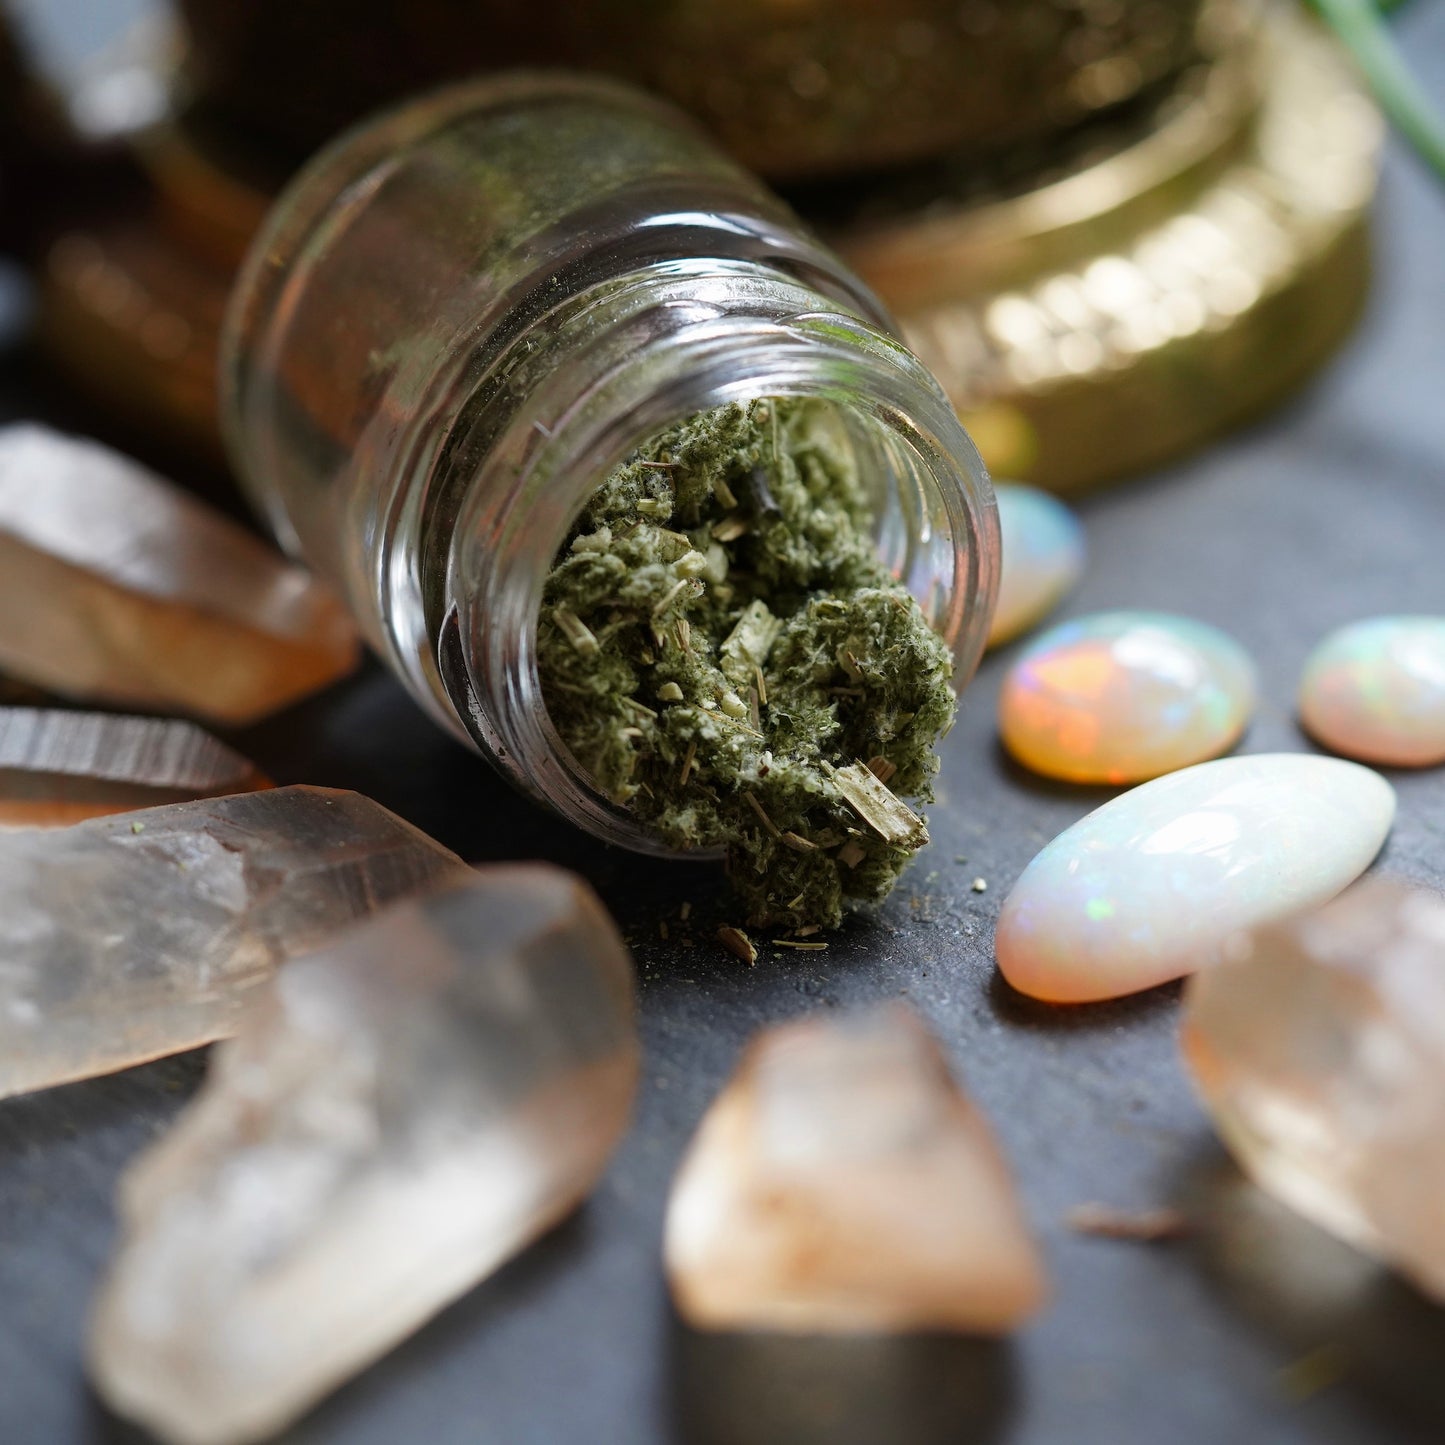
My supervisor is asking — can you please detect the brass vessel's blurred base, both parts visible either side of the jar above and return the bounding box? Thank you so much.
[42,0,1381,491]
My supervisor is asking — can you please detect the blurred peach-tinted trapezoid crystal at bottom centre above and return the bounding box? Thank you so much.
[666,1006,1045,1334]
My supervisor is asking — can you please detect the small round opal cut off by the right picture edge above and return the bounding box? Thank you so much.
[1299,617,1445,767]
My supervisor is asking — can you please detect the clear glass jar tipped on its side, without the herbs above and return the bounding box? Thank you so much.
[223,74,998,853]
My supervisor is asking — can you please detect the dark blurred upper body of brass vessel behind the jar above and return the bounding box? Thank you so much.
[181,0,1201,179]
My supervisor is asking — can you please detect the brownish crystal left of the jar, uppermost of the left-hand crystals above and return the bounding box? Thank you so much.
[0,425,358,724]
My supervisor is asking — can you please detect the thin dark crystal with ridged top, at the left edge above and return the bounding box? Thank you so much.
[0,708,270,828]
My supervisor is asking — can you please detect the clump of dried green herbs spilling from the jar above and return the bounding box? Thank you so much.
[538,399,954,933]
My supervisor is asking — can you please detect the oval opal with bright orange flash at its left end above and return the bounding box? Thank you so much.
[998,613,1254,783]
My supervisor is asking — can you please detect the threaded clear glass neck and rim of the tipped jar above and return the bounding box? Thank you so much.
[419,262,997,853]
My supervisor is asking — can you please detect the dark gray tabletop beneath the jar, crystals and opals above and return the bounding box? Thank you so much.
[0,14,1445,1445]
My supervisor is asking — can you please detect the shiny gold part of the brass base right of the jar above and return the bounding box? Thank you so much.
[831,6,1383,491]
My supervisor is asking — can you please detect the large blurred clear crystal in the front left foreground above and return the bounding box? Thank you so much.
[90,864,639,1445]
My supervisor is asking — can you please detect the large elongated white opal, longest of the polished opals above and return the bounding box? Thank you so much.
[994,753,1394,1003]
